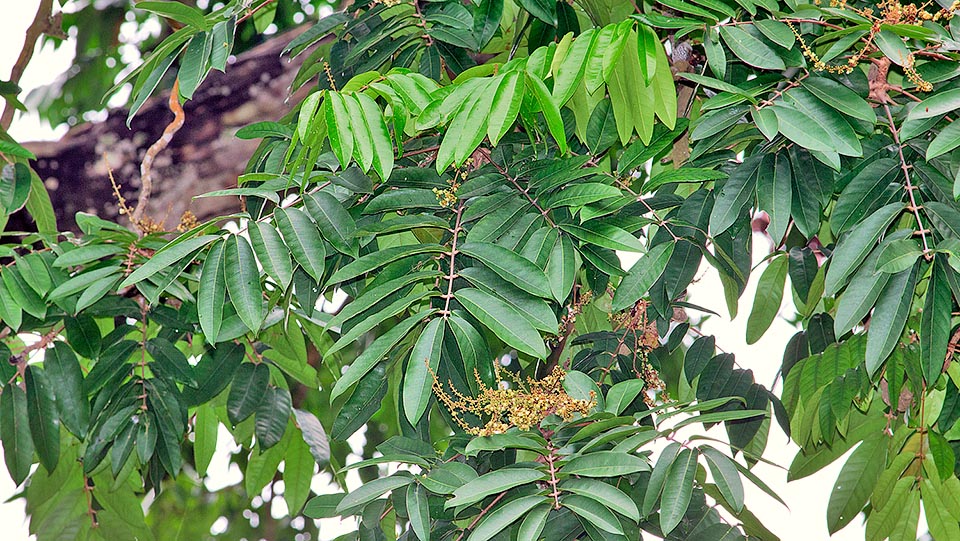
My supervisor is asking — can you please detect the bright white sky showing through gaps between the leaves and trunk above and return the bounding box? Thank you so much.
[0,0,896,541]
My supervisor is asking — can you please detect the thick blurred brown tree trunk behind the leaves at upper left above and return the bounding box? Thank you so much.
[17,26,312,231]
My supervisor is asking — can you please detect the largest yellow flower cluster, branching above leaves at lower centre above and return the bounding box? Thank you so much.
[433,365,597,436]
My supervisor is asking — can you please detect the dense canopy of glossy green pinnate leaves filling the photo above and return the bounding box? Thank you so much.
[0,0,960,541]
